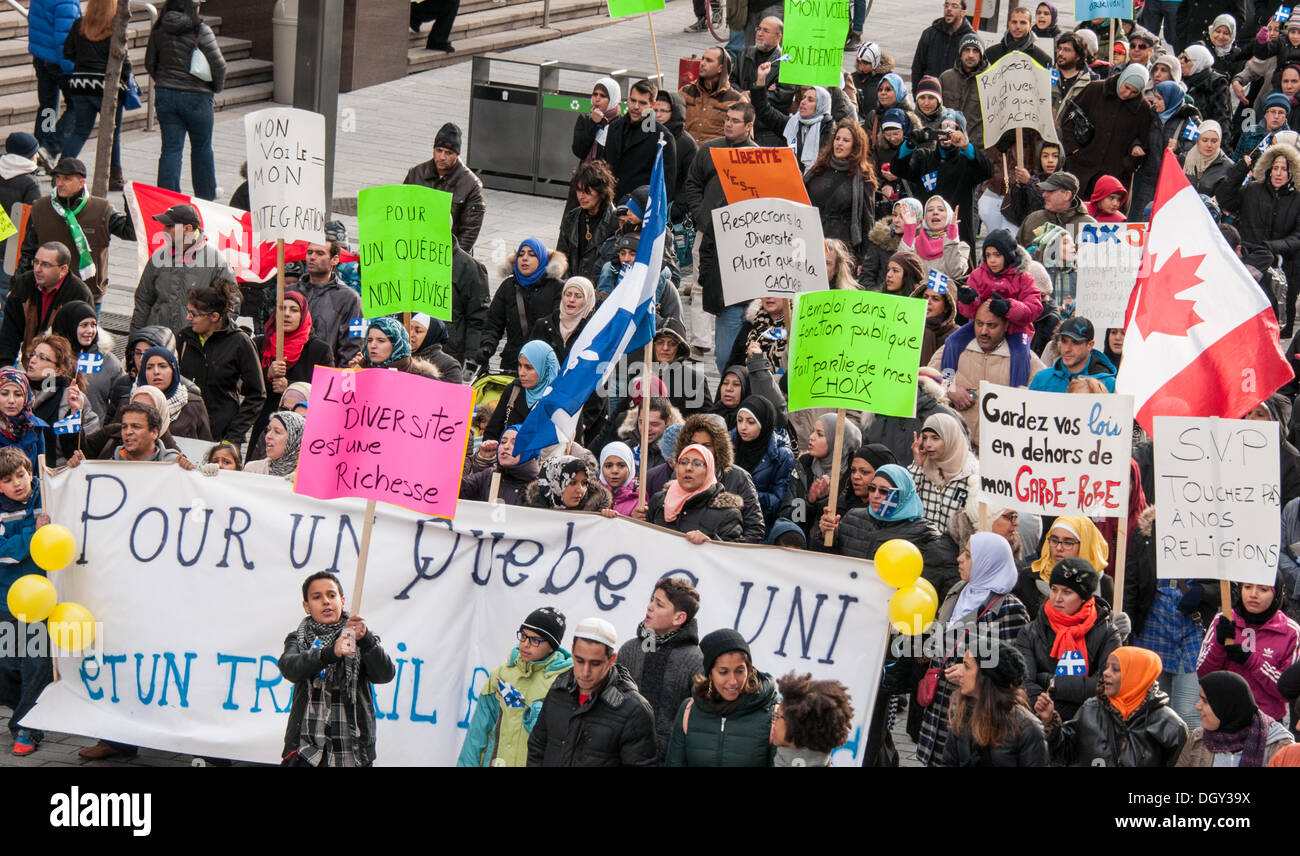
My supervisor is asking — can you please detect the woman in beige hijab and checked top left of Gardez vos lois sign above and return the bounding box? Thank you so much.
[907,412,979,532]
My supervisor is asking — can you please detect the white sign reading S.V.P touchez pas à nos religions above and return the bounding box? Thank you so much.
[1151,416,1282,585]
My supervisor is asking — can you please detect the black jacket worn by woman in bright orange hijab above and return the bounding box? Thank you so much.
[1047,684,1187,768]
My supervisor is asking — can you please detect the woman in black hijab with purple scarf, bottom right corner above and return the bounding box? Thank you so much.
[1175,671,1295,766]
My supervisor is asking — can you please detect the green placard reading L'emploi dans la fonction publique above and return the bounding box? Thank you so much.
[787,290,926,416]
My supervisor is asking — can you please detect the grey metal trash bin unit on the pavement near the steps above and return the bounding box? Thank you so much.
[467,53,662,199]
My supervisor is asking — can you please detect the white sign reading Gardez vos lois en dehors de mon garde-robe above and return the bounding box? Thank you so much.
[979,381,1134,518]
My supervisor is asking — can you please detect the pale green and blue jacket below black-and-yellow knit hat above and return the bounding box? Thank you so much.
[456,645,573,766]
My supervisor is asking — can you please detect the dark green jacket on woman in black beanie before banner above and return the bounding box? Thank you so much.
[664,673,776,766]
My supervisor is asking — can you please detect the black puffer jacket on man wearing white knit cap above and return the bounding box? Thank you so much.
[528,663,658,766]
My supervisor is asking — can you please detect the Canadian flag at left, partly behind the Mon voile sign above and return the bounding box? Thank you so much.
[125,181,358,282]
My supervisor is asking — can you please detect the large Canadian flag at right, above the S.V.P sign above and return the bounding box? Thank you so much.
[1115,151,1292,436]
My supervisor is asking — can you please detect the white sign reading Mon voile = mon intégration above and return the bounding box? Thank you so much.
[244,107,325,243]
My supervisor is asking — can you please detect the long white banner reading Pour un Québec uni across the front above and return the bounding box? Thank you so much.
[26,462,893,766]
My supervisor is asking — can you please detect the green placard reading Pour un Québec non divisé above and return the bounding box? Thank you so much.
[356,185,451,321]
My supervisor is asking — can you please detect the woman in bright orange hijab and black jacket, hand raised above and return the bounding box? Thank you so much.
[1021,648,1187,768]
